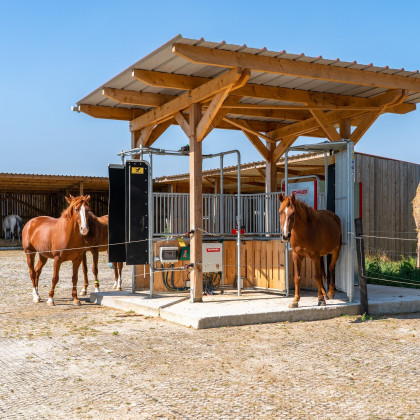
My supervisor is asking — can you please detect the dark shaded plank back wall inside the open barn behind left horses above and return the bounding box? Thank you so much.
[0,192,108,236]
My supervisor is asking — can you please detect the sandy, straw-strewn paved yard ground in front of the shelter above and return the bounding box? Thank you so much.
[0,251,420,420]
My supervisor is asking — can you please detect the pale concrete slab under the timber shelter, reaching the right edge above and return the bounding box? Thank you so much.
[91,285,420,328]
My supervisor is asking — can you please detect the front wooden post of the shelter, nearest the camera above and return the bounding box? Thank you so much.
[189,104,203,302]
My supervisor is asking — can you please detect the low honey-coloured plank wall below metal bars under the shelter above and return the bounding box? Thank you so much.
[135,240,316,292]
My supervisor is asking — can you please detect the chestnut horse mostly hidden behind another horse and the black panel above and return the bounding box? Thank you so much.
[80,213,123,296]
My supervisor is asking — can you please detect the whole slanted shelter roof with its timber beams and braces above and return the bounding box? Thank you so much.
[75,35,420,162]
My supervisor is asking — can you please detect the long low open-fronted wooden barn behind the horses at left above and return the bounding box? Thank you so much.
[0,173,108,235]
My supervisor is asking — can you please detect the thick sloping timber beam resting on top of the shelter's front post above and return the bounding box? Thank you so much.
[130,69,250,131]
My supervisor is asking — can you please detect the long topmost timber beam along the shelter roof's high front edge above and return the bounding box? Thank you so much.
[172,43,420,92]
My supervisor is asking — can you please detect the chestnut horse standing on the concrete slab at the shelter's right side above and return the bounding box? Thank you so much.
[279,194,341,308]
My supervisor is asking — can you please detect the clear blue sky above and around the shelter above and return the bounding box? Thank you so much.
[0,0,420,176]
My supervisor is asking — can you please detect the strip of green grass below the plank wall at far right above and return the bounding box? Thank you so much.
[366,256,420,288]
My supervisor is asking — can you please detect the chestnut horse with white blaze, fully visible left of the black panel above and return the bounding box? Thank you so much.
[22,195,90,306]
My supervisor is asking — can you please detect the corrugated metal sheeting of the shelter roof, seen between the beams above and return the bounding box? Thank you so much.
[77,35,420,115]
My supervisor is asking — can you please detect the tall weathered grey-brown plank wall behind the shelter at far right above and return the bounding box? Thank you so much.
[355,153,420,259]
